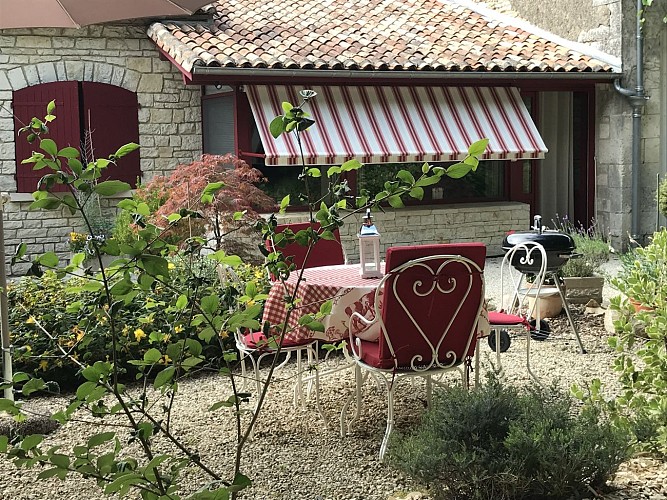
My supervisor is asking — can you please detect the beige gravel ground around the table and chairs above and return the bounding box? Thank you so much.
[0,259,667,500]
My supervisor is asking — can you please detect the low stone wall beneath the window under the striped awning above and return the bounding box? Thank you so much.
[279,202,531,263]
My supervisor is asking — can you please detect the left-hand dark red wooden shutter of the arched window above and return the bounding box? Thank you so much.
[13,82,81,193]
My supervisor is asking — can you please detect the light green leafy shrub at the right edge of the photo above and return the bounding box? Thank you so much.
[578,229,667,457]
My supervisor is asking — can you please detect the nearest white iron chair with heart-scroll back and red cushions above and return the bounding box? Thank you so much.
[340,243,486,460]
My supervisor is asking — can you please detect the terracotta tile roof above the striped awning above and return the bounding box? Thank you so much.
[148,0,618,72]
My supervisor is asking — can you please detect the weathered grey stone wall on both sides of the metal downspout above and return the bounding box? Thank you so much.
[596,0,667,249]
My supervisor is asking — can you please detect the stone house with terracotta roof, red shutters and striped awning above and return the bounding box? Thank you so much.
[0,0,627,272]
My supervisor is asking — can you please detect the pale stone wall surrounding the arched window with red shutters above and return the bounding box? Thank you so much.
[0,23,202,274]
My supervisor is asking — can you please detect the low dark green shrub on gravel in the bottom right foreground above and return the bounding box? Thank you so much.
[389,379,628,500]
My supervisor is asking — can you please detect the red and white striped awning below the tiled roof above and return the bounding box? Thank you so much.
[246,85,547,165]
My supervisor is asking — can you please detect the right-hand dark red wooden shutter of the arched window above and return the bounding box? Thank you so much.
[81,82,141,187]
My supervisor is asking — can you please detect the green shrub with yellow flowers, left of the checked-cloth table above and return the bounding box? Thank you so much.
[8,257,269,388]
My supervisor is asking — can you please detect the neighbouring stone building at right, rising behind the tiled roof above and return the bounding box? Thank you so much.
[480,0,667,246]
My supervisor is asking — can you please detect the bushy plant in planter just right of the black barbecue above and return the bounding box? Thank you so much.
[556,217,611,304]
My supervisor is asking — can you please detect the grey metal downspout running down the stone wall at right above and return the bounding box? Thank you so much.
[614,0,649,241]
